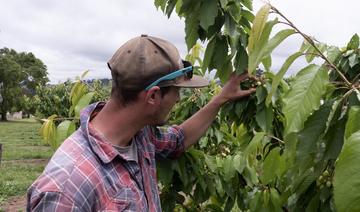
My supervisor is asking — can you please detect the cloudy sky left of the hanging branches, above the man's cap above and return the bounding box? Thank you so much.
[0,0,186,83]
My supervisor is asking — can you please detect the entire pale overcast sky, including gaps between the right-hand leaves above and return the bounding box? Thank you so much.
[0,0,360,83]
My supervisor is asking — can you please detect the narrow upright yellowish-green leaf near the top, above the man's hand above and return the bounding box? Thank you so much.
[248,4,271,53]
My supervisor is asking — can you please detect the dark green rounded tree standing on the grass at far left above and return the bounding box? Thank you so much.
[0,48,49,120]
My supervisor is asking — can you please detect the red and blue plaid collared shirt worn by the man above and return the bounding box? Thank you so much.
[27,103,184,211]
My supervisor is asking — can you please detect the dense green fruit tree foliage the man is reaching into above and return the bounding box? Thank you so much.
[156,0,360,211]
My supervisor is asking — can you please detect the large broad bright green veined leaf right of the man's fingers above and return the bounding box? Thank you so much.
[283,64,329,135]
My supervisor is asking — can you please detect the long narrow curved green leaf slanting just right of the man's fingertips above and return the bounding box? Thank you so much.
[265,52,302,106]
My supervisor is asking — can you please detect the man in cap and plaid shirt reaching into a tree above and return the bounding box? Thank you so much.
[27,35,254,211]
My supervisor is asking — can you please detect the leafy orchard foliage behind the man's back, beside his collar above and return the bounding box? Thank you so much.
[36,72,110,150]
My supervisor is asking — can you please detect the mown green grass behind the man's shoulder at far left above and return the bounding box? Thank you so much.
[0,120,53,206]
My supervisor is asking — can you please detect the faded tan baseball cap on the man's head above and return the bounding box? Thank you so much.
[108,35,209,90]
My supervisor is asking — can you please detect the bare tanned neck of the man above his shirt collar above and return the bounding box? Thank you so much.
[91,100,145,146]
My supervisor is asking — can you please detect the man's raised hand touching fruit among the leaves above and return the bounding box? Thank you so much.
[215,73,256,104]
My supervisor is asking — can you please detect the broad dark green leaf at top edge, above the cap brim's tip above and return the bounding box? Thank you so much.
[200,0,218,31]
